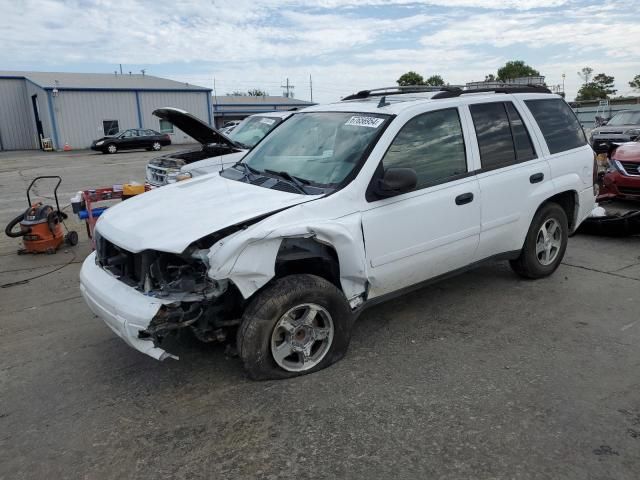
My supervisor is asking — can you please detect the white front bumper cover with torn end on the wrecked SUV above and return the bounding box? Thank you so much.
[80,252,177,360]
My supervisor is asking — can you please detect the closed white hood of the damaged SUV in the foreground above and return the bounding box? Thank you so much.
[97,173,322,253]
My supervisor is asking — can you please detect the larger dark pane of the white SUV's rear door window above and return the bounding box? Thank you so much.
[469,103,516,170]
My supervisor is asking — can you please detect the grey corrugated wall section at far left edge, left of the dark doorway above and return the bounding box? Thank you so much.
[0,79,38,150]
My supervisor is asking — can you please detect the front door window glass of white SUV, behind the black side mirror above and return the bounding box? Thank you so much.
[382,108,467,189]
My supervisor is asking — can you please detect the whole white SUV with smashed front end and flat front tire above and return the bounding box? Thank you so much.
[80,87,594,379]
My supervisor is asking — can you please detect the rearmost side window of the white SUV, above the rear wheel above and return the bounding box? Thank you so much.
[525,98,587,153]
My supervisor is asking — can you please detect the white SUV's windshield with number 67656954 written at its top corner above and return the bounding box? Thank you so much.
[243,112,389,187]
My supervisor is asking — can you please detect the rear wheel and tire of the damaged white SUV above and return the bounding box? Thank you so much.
[509,202,569,279]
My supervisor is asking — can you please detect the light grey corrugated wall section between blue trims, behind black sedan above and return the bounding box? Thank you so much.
[51,90,138,149]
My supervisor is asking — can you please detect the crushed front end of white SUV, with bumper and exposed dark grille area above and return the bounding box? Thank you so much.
[80,234,243,360]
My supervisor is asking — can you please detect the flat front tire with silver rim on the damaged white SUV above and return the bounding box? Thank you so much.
[237,275,354,380]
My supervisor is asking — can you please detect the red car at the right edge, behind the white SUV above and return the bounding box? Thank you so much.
[598,142,640,200]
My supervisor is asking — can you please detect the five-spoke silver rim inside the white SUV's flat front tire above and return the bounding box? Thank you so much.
[271,303,334,372]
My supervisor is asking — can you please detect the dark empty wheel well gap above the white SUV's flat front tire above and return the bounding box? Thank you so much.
[275,238,342,290]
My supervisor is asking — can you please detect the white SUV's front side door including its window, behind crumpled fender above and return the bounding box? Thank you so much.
[362,108,480,297]
